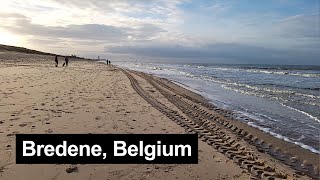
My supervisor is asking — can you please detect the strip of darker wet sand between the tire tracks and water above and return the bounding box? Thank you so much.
[124,70,320,178]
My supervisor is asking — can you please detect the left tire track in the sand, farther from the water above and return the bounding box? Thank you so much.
[122,70,292,179]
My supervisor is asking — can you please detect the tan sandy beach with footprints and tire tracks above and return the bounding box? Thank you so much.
[0,51,320,179]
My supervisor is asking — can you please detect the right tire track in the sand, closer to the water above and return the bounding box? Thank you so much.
[133,71,320,179]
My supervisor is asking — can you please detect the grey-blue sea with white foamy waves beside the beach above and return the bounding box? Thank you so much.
[116,62,320,154]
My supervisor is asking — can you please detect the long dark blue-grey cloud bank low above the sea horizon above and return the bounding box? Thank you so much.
[105,43,320,64]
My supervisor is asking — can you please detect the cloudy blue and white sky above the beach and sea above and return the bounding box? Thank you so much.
[0,0,320,65]
